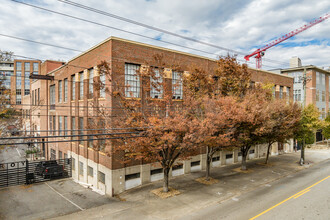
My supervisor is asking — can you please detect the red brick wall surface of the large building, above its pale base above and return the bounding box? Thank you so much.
[43,39,293,169]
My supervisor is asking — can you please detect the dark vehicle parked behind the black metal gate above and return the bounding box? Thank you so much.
[34,160,64,179]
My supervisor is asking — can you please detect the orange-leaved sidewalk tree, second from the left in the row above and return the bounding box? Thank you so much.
[184,56,251,180]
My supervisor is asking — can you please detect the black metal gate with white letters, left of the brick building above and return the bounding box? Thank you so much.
[0,158,72,188]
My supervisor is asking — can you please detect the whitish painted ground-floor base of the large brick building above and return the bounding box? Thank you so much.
[68,141,293,196]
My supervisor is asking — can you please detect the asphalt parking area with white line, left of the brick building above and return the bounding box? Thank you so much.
[0,179,117,219]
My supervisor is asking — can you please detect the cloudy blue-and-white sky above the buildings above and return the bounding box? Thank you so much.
[0,0,330,70]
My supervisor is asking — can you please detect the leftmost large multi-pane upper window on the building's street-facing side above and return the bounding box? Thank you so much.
[125,63,140,98]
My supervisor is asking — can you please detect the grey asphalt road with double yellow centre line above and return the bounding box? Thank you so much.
[180,160,330,220]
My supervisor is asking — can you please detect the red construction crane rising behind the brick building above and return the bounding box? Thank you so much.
[244,14,330,69]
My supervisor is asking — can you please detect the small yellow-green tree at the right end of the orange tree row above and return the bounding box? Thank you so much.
[295,104,322,165]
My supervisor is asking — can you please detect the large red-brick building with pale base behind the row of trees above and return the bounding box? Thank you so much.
[31,37,293,196]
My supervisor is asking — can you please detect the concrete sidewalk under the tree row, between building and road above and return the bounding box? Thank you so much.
[51,150,330,220]
